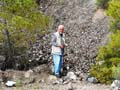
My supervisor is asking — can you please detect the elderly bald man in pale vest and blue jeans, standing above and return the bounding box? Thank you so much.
[51,25,66,77]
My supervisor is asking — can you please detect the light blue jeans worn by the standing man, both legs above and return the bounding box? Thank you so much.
[53,54,63,76]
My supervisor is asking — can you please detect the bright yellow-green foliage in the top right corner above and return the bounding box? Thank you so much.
[106,0,120,32]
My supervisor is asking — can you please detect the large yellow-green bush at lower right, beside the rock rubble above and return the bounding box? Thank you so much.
[90,30,120,84]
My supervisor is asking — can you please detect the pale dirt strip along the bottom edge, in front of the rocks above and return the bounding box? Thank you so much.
[0,82,110,90]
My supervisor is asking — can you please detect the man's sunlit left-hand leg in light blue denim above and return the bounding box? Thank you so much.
[53,54,61,76]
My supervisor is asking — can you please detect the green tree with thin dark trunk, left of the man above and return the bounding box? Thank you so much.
[0,0,50,68]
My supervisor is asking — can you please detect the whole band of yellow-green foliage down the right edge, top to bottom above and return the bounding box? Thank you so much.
[90,0,120,84]
